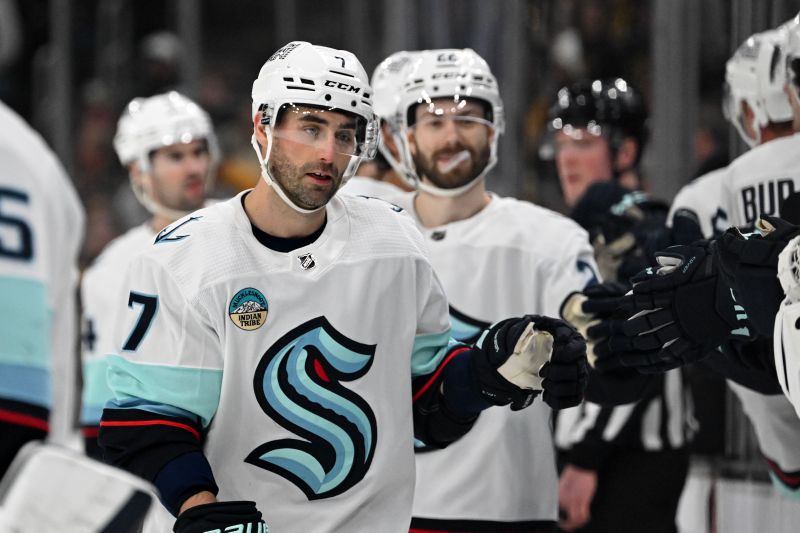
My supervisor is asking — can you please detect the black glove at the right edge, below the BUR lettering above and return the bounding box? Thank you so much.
[716,215,800,337]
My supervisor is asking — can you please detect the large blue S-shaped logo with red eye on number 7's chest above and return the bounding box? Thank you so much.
[245,317,377,500]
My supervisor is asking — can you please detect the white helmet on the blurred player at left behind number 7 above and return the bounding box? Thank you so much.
[114,91,219,219]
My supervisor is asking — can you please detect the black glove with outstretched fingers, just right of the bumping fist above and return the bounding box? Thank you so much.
[609,241,751,372]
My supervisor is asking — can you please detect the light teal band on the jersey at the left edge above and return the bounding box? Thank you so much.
[0,277,53,369]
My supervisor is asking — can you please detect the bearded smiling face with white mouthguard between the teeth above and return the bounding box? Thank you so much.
[408,98,495,189]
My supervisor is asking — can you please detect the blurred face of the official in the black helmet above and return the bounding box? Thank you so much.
[555,129,614,207]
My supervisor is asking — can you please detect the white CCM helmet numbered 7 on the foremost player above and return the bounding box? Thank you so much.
[252,41,379,213]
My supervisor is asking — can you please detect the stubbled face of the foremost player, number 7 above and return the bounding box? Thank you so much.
[269,106,357,209]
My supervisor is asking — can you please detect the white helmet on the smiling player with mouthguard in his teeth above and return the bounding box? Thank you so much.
[399,48,505,197]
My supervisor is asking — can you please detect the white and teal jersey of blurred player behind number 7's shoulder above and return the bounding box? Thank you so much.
[80,222,156,426]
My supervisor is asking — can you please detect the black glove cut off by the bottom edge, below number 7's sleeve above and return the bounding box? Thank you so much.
[172,501,269,533]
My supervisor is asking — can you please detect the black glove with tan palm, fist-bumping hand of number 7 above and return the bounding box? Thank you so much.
[470,315,587,411]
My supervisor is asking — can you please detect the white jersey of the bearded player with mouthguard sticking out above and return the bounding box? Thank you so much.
[389,193,597,522]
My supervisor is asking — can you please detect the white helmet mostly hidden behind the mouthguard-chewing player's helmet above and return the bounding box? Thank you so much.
[372,50,419,181]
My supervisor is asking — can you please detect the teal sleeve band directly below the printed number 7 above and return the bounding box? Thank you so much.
[106,355,222,427]
